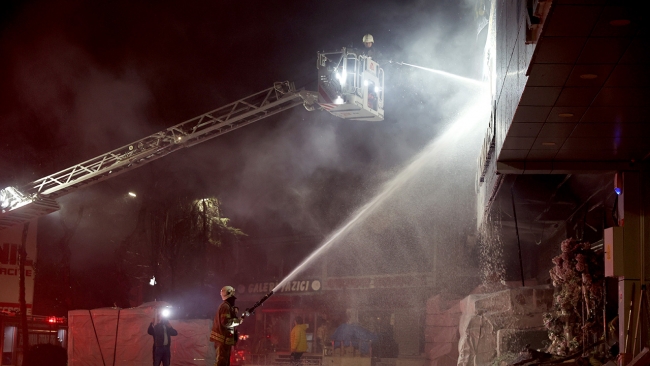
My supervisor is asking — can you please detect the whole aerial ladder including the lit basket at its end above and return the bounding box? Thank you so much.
[0,48,384,230]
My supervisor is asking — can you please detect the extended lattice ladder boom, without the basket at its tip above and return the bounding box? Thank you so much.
[0,81,318,230]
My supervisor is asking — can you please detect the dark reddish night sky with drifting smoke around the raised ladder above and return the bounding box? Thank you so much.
[0,0,482,308]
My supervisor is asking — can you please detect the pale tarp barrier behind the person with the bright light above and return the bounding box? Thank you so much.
[68,303,214,366]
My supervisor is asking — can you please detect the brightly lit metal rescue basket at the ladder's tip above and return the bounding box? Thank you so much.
[317,47,384,121]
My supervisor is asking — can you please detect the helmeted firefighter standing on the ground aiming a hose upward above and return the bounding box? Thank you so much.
[210,286,244,366]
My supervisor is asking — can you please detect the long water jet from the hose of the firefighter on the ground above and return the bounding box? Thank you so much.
[273,86,489,292]
